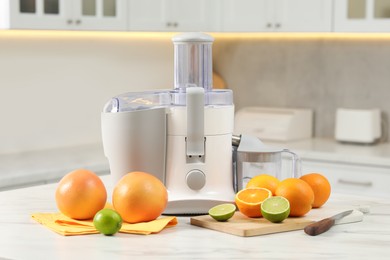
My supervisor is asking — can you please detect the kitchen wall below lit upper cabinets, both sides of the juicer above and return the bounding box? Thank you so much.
[0,31,390,154]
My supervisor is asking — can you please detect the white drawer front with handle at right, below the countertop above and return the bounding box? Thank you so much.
[302,160,390,198]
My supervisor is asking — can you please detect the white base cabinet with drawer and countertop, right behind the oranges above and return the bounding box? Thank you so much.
[278,138,390,198]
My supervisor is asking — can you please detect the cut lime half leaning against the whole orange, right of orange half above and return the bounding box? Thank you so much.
[261,196,290,223]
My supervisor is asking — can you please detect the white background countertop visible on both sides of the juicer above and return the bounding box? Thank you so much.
[0,138,390,190]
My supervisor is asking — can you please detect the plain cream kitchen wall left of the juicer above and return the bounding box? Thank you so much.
[0,31,173,154]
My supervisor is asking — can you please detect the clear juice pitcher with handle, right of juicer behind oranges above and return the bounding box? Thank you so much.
[233,135,301,192]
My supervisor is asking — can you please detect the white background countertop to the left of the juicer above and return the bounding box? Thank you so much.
[0,144,109,190]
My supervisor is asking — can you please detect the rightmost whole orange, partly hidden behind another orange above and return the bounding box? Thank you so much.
[300,173,331,208]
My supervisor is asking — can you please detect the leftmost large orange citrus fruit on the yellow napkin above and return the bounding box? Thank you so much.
[55,169,107,219]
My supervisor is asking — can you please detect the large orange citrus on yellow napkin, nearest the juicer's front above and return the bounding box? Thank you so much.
[112,172,168,223]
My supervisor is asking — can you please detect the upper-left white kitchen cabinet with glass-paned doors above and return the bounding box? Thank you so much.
[0,0,127,30]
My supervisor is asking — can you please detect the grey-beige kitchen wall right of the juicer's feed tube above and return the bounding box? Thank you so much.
[214,34,390,137]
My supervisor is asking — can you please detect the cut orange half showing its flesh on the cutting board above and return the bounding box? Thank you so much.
[235,188,272,218]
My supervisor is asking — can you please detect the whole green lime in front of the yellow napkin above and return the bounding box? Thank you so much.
[93,209,122,236]
